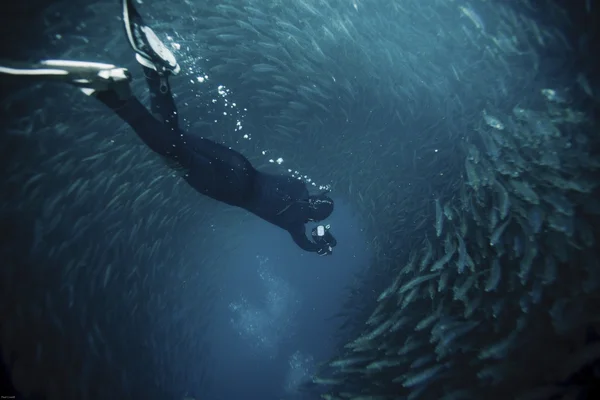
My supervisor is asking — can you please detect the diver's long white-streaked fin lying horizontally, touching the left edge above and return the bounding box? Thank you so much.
[0,60,131,99]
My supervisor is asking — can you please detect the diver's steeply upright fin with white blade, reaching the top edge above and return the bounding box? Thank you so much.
[123,0,180,75]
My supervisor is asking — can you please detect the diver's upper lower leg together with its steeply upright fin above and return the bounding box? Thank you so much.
[122,0,180,132]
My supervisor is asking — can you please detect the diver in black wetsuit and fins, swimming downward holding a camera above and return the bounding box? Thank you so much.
[0,0,336,255]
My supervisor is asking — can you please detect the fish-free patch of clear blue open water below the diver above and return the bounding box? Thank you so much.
[206,199,369,400]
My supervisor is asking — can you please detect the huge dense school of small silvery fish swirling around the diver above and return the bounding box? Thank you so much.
[0,0,600,400]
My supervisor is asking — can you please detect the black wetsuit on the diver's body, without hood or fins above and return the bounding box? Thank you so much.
[96,68,323,252]
